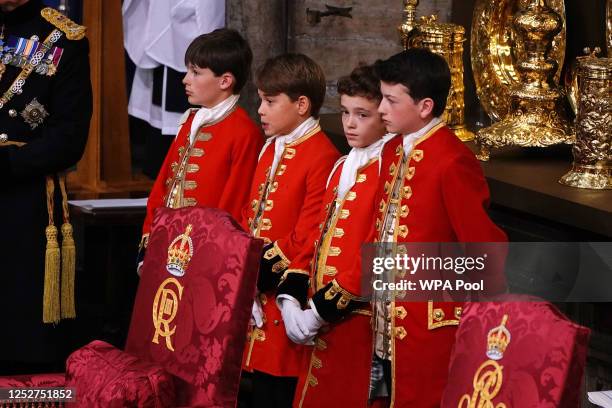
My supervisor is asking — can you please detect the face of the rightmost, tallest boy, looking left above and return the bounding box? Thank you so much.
[378,81,432,135]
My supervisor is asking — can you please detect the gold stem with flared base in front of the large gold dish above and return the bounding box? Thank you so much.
[476,0,575,160]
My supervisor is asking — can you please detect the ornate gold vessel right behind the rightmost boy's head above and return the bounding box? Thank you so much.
[398,0,474,141]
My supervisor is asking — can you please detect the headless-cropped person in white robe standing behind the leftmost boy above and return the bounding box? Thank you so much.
[122,0,225,179]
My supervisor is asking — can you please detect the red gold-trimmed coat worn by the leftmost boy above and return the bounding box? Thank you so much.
[142,107,263,242]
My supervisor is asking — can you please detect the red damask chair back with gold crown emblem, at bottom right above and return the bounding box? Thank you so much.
[442,298,590,408]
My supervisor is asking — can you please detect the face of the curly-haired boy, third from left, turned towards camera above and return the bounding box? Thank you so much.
[340,95,385,147]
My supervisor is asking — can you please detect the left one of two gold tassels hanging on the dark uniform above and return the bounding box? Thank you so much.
[43,176,60,323]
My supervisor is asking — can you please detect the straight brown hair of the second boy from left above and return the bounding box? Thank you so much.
[255,54,325,118]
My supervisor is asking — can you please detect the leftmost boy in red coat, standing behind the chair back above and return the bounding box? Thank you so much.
[138,28,263,267]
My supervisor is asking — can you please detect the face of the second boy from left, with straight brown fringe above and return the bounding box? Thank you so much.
[257,89,309,136]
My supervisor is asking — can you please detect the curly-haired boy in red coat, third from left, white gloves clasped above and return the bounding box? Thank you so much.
[277,66,393,408]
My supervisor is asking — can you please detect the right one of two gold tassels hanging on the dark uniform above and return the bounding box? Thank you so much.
[59,175,76,319]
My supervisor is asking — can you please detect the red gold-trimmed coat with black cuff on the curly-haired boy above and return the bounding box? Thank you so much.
[288,159,379,407]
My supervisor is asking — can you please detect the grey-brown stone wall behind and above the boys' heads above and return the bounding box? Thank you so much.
[226,0,452,113]
